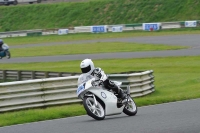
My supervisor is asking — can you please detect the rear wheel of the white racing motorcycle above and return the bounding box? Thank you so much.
[123,96,137,116]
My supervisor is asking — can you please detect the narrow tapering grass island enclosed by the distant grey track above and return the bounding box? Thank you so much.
[10,42,188,57]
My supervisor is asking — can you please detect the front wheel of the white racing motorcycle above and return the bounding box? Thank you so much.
[83,97,105,120]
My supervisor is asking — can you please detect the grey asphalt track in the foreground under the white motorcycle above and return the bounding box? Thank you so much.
[0,99,200,133]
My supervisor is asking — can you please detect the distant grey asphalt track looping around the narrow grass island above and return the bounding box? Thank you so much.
[0,34,200,63]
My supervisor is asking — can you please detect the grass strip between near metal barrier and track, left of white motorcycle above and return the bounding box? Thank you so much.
[0,104,85,126]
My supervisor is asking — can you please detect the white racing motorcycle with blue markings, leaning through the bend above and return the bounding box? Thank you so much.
[77,78,137,120]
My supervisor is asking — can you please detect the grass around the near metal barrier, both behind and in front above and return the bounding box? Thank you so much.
[0,56,200,126]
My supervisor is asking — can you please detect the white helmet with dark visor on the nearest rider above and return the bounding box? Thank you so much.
[80,59,95,74]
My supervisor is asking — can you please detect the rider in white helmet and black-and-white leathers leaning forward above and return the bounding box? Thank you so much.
[78,59,127,102]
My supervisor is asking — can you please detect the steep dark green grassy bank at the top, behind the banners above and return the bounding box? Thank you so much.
[0,0,200,31]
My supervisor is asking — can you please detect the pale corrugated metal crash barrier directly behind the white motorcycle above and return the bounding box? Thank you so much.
[0,70,154,112]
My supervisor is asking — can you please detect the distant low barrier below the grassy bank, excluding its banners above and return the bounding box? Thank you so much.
[0,20,200,38]
